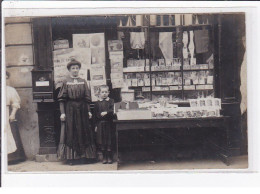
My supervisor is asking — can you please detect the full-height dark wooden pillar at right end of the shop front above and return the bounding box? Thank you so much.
[219,14,245,155]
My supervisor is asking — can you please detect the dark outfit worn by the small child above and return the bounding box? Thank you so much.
[94,98,114,151]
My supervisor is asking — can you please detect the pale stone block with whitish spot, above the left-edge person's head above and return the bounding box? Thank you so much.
[5,46,33,66]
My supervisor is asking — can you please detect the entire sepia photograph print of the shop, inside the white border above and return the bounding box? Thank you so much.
[3,12,248,172]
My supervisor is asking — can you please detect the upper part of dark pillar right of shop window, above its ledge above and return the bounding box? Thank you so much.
[220,14,243,102]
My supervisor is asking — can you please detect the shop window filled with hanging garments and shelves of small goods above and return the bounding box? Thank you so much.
[118,14,214,103]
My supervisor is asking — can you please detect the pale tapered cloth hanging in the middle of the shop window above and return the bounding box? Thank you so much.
[159,32,173,60]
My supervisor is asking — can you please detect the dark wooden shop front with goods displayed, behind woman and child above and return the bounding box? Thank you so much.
[9,14,245,164]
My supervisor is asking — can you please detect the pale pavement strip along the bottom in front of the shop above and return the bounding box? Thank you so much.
[8,155,248,173]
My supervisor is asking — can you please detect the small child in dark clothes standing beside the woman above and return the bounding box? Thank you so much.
[94,85,114,164]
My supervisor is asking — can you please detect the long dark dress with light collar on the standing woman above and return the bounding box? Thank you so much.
[58,77,96,160]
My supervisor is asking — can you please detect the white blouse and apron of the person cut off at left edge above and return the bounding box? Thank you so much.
[5,86,21,154]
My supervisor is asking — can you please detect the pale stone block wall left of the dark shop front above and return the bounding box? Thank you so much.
[5,18,39,160]
